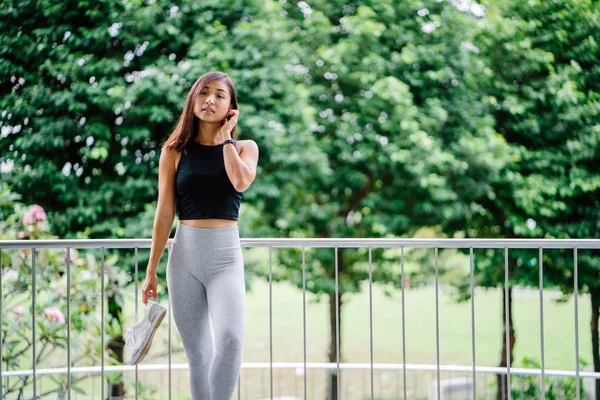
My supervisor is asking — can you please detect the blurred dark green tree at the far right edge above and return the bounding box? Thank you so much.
[446,0,600,399]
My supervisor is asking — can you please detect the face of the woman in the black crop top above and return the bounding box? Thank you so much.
[194,80,231,123]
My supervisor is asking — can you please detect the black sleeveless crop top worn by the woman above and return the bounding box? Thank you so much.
[175,140,242,221]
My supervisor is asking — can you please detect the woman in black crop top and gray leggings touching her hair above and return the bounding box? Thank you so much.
[142,72,258,400]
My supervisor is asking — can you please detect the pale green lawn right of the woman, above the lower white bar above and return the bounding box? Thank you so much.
[244,281,592,370]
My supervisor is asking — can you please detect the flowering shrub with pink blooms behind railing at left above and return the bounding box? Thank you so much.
[0,204,129,398]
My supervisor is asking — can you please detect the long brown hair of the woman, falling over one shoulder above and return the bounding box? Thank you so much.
[162,71,238,152]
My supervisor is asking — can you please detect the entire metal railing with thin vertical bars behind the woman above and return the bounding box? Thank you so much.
[0,239,600,400]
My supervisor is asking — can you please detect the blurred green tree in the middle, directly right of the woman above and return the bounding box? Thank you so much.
[264,1,509,399]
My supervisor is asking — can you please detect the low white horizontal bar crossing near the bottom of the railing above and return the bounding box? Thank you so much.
[2,362,600,379]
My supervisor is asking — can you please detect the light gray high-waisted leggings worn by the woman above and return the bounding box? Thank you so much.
[167,223,246,400]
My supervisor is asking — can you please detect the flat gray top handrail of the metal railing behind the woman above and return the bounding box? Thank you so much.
[0,238,600,249]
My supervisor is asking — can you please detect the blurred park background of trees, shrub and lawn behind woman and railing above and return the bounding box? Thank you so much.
[0,0,600,400]
